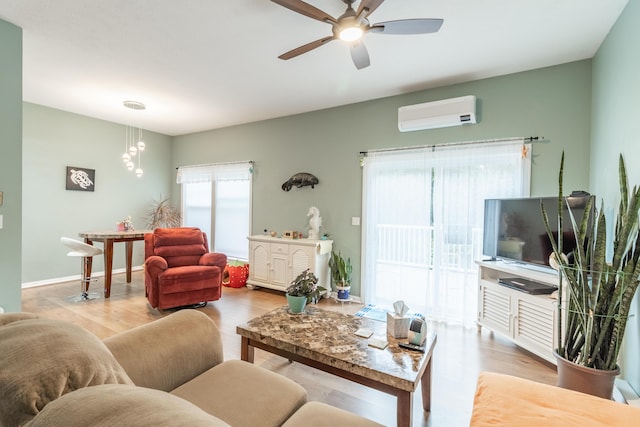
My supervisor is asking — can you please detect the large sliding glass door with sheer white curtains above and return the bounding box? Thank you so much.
[362,139,530,325]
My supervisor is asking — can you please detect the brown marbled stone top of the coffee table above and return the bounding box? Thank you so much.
[236,306,437,391]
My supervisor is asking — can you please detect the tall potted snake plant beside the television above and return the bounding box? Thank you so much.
[542,153,640,399]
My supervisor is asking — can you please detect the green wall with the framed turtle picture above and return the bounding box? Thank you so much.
[18,103,171,286]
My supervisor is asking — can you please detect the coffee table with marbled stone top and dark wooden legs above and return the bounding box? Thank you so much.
[236,306,437,427]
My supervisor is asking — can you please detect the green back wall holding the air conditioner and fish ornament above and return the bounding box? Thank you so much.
[172,60,591,295]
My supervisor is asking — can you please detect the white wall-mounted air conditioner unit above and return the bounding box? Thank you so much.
[398,95,476,132]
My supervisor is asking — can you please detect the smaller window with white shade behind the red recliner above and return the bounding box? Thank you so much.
[177,162,253,260]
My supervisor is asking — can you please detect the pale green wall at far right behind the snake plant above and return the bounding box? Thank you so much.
[589,0,640,392]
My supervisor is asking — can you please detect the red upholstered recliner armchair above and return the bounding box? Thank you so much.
[144,227,227,310]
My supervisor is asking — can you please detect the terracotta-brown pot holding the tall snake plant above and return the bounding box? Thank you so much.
[553,352,620,399]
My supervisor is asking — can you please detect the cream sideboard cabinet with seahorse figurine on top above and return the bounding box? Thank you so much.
[247,236,333,291]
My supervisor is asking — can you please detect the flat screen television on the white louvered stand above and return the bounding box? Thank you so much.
[482,191,595,268]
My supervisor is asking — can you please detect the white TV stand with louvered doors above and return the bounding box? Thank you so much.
[477,261,558,364]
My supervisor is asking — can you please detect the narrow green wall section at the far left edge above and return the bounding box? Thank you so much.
[0,20,22,311]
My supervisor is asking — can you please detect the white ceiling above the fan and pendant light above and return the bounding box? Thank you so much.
[0,0,627,135]
